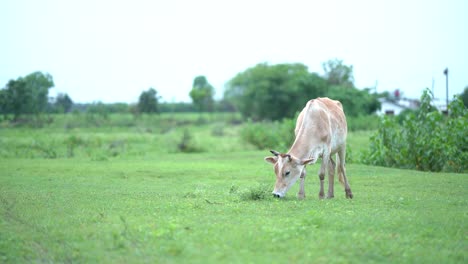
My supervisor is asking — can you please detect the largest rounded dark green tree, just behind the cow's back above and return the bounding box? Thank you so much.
[224,63,326,121]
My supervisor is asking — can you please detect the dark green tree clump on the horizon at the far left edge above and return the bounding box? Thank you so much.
[0,72,54,121]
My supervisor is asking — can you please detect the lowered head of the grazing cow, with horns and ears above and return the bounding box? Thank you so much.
[265,150,315,198]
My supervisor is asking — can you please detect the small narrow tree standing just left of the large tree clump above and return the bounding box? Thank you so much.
[189,76,214,112]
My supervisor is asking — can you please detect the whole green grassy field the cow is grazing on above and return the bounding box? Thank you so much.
[0,114,468,263]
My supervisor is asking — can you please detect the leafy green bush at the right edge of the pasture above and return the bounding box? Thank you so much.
[364,87,468,172]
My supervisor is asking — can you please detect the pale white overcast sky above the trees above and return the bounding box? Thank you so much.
[0,0,468,102]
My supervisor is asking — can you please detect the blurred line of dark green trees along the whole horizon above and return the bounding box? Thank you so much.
[0,59,468,122]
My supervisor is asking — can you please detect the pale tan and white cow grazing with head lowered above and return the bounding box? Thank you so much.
[265,98,353,199]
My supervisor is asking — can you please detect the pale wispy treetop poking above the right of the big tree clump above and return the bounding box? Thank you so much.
[322,59,354,87]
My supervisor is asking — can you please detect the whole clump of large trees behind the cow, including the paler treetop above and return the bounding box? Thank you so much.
[224,60,380,121]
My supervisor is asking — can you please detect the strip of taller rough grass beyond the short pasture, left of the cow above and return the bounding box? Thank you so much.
[0,114,254,160]
